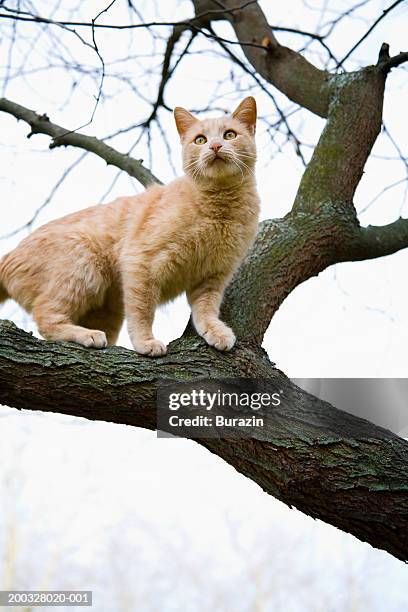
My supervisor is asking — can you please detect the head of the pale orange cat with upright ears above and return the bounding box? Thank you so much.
[174,96,256,182]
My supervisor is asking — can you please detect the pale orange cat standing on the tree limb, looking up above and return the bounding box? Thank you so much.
[0,97,259,356]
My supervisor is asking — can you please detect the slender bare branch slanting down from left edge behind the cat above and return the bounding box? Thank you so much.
[0,98,160,187]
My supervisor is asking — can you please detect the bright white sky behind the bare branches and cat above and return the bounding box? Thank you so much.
[0,0,408,610]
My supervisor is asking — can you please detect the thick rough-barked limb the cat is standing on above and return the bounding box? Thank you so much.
[0,321,408,561]
